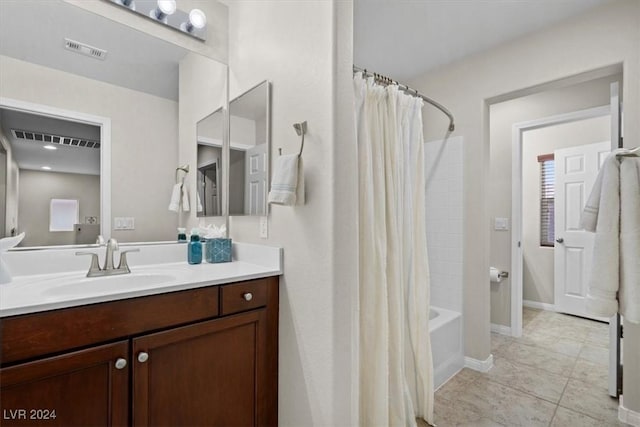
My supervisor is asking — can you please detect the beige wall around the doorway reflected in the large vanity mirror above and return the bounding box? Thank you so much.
[0,56,178,242]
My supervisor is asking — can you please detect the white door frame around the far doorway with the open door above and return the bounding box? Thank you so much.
[511,105,618,337]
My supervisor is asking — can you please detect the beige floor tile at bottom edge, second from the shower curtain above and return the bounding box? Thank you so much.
[452,378,556,426]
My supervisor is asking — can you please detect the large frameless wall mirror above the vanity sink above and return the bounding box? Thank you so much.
[0,0,227,247]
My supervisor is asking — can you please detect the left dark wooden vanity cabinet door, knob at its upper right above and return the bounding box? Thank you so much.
[0,341,129,427]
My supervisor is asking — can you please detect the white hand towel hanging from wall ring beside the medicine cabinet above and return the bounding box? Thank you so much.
[268,154,304,206]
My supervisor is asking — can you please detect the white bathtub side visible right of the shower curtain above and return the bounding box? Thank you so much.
[429,306,464,389]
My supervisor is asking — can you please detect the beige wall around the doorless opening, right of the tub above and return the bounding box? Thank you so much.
[409,0,640,411]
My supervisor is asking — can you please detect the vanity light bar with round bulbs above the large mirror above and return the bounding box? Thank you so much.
[106,0,207,41]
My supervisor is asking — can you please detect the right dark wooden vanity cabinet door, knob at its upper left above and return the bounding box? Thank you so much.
[133,309,267,426]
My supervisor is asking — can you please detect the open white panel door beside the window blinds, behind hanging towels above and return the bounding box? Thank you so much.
[554,141,611,321]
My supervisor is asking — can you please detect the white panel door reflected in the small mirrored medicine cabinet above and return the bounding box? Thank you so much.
[244,144,267,215]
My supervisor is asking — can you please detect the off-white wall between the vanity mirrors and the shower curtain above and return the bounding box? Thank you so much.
[228,0,357,426]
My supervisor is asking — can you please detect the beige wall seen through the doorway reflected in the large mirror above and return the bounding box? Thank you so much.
[18,169,100,246]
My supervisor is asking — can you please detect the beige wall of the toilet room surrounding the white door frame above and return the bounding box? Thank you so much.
[488,75,622,326]
